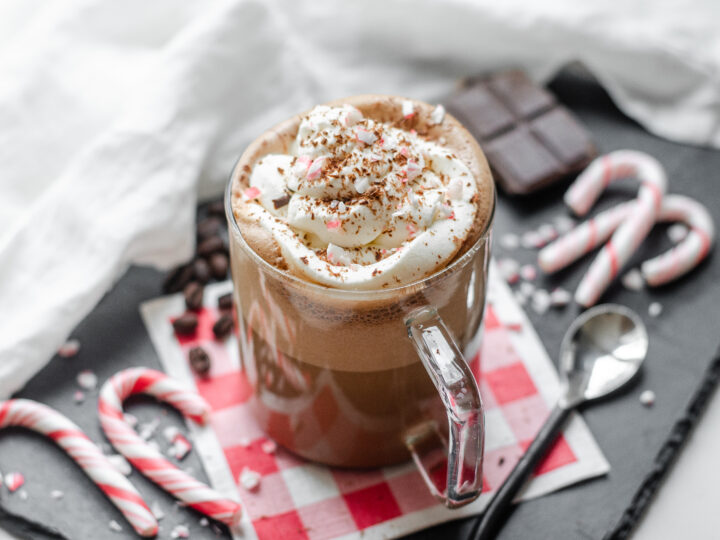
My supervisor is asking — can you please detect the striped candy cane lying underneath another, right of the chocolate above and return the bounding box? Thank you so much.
[538,195,715,287]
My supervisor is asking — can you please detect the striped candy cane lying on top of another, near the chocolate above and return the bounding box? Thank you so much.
[565,150,667,307]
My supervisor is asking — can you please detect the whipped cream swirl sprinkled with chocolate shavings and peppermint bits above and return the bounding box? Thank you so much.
[243,104,478,289]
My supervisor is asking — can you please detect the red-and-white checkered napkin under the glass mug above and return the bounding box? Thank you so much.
[141,260,610,540]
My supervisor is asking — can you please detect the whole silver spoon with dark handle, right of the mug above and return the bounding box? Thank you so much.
[470,304,648,540]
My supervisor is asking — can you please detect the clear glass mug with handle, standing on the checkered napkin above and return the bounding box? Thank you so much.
[225,158,494,508]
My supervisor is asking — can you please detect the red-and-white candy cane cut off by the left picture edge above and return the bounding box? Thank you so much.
[0,399,158,536]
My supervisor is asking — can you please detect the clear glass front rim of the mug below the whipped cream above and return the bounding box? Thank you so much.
[225,154,497,298]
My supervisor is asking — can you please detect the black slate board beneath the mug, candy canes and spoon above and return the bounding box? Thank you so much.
[0,74,720,540]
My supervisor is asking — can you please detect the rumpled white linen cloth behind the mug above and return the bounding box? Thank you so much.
[0,0,720,397]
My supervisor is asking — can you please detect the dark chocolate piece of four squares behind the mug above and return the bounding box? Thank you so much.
[446,71,597,194]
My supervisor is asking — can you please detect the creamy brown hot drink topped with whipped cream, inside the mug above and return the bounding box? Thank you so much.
[228,95,494,466]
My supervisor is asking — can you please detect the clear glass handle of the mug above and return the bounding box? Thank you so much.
[405,306,485,508]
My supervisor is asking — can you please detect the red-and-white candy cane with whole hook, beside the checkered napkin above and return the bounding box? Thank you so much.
[98,368,241,526]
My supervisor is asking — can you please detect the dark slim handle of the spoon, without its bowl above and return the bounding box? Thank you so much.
[470,405,572,540]
